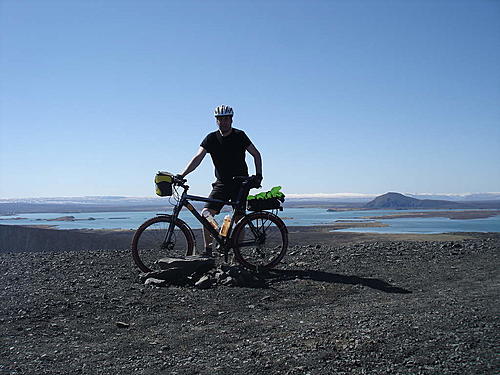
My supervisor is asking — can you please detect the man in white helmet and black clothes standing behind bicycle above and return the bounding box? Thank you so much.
[179,105,262,256]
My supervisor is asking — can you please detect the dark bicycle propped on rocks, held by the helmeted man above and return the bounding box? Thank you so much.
[132,176,288,272]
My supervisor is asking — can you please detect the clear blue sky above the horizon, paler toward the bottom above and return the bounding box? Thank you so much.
[0,0,500,198]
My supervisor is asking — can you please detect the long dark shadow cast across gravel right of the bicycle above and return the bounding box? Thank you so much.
[265,270,412,294]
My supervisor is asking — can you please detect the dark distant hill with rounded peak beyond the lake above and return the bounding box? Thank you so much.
[363,192,464,209]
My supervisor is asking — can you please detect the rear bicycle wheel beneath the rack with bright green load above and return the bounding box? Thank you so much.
[232,211,288,270]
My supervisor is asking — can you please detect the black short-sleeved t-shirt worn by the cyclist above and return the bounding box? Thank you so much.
[200,128,252,182]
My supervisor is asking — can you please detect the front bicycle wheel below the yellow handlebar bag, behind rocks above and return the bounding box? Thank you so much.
[131,215,195,272]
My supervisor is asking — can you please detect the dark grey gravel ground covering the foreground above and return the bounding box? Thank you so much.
[0,233,500,375]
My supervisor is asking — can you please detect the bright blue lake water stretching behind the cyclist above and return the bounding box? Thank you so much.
[0,208,500,233]
